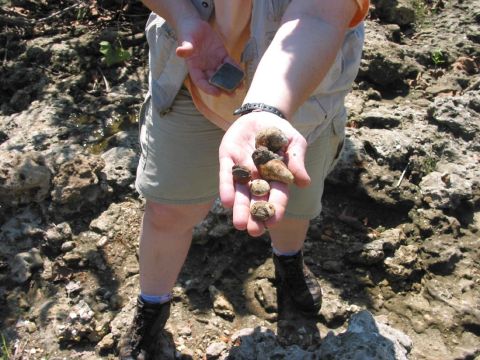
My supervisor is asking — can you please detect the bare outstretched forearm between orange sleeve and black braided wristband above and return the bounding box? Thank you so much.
[244,0,356,119]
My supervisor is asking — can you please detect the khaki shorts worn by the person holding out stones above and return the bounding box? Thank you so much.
[135,89,344,219]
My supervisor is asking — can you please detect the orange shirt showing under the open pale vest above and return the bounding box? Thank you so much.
[185,0,370,130]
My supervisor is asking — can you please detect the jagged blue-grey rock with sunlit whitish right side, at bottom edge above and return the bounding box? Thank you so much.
[316,311,412,360]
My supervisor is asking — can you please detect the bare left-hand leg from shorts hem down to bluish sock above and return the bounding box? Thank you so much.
[140,201,212,295]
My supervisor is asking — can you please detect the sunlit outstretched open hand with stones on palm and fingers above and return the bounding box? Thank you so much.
[219,112,310,236]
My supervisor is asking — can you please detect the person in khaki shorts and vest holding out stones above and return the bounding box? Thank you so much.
[119,0,369,359]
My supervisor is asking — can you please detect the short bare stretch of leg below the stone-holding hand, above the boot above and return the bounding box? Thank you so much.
[269,218,310,253]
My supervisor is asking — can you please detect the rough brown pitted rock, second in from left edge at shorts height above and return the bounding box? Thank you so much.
[51,155,108,215]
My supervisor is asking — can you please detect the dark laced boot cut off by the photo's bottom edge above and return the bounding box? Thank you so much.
[119,296,170,360]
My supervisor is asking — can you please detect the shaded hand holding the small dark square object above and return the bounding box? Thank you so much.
[176,18,238,96]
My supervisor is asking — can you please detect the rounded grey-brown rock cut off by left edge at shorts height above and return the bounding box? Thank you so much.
[0,150,51,207]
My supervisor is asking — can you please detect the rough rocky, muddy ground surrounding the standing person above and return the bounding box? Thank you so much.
[0,0,480,360]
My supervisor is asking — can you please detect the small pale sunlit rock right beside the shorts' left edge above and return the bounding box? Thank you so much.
[102,147,138,188]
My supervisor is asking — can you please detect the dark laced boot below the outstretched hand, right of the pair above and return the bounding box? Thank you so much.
[273,251,322,314]
